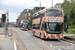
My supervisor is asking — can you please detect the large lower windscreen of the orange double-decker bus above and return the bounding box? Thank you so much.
[45,22,63,32]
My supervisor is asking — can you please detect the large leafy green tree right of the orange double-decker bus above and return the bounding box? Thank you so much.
[62,1,75,25]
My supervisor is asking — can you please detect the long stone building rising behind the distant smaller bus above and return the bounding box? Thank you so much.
[16,9,32,25]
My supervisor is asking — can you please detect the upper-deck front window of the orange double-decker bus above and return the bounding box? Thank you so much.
[46,9,62,17]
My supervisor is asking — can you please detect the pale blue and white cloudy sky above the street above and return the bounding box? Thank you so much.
[0,0,64,22]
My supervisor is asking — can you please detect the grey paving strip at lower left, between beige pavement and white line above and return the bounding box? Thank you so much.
[1,37,14,50]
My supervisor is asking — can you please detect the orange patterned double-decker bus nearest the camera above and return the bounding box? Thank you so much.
[32,8,64,39]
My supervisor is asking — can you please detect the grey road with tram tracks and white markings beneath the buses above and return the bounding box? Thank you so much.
[11,28,75,50]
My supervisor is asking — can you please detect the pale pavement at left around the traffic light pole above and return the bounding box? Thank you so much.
[0,27,14,50]
